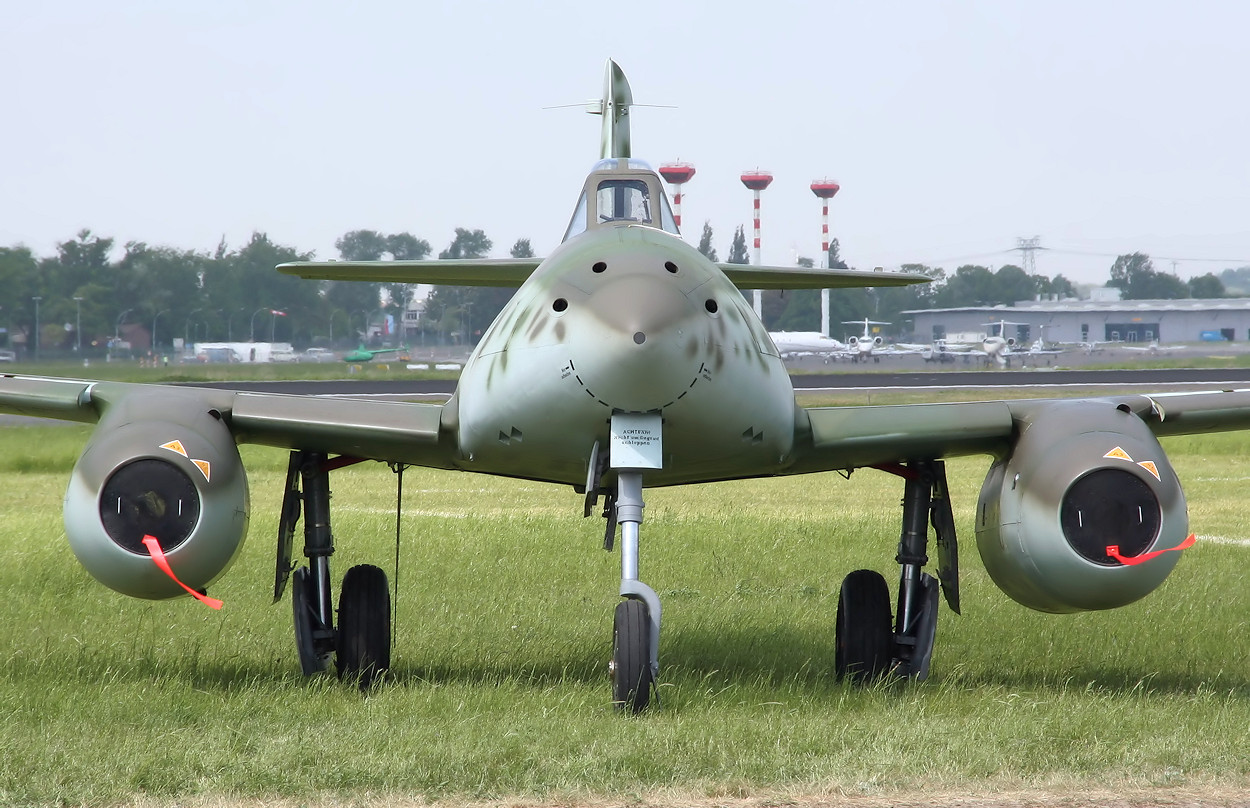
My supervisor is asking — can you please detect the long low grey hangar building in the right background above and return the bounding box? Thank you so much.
[903,298,1250,343]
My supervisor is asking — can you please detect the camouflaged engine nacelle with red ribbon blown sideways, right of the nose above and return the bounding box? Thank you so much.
[976,401,1189,613]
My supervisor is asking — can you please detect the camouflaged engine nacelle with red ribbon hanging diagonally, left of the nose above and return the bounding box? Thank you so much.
[65,394,249,599]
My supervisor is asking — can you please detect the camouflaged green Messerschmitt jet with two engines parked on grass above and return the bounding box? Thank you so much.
[0,63,1250,712]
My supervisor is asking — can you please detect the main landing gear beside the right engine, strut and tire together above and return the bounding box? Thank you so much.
[834,460,959,683]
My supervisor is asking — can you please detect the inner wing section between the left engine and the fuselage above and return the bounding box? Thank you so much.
[230,393,455,468]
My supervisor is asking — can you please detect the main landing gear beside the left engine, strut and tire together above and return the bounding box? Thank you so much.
[274,450,391,688]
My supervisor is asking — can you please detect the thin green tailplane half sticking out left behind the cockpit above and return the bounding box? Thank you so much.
[278,258,543,288]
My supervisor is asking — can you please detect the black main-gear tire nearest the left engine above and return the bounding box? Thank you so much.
[335,564,390,689]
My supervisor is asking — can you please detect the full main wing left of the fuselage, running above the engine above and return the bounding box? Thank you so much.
[0,375,455,468]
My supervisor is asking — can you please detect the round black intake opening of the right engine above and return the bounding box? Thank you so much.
[1059,469,1163,567]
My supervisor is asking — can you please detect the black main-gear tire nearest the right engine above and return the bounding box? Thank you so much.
[834,569,894,684]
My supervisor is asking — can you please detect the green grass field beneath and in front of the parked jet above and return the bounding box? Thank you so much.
[0,390,1250,805]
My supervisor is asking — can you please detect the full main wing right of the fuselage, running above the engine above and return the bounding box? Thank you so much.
[789,390,1250,474]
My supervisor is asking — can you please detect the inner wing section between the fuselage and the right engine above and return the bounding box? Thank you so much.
[789,401,1013,473]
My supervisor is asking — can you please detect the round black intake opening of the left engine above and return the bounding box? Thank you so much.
[100,458,200,555]
